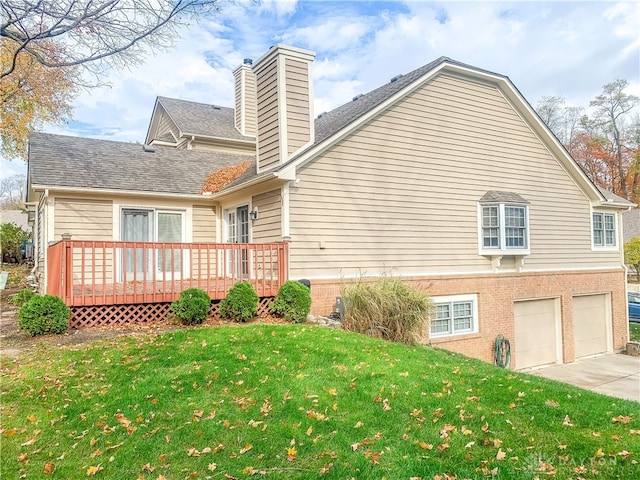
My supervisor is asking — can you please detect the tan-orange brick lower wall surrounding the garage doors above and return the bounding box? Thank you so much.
[311,269,628,365]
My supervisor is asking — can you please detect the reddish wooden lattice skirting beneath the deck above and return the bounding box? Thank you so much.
[70,297,273,328]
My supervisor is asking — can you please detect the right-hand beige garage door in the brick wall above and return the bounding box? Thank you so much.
[573,294,609,358]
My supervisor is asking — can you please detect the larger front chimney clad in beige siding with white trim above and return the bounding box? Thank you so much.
[253,45,315,172]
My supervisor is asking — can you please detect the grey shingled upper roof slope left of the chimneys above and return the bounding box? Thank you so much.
[154,97,255,142]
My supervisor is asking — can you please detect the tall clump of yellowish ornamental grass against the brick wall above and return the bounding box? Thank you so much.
[342,277,432,344]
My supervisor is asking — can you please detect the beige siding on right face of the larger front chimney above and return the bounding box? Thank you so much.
[285,58,311,155]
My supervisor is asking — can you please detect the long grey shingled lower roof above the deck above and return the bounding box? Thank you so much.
[28,132,255,195]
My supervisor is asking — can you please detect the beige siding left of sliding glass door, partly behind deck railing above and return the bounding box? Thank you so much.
[54,198,113,284]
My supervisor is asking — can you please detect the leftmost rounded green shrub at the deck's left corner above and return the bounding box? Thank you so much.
[18,295,71,337]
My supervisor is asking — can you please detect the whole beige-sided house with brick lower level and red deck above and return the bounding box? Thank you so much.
[29,45,631,369]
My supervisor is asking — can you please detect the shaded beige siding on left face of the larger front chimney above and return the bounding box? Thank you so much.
[256,59,280,169]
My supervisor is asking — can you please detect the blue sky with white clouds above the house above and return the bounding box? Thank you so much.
[0,0,640,177]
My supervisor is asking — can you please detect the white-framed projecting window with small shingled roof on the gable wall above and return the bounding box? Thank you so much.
[478,191,529,255]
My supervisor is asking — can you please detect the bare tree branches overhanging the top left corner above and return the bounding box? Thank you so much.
[0,0,221,79]
